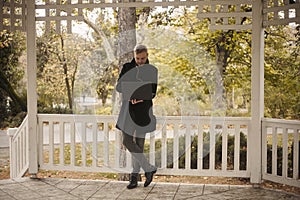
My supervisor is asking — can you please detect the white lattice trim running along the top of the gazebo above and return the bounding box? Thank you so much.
[0,0,300,33]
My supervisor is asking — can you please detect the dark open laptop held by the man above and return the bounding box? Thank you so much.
[121,81,152,100]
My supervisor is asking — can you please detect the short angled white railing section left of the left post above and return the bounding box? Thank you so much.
[7,116,29,178]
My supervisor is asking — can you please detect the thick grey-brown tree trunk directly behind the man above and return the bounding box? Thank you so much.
[117,3,136,180]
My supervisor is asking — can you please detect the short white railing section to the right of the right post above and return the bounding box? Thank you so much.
[262,119,300,187]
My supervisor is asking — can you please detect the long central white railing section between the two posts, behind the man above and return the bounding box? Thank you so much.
[38,114,250,177]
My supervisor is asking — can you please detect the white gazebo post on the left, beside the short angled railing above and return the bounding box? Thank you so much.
[26,0,38,176]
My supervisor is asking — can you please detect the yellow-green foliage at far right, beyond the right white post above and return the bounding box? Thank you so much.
[265,26,300,119]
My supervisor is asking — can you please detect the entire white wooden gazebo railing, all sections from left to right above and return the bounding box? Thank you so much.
[8,114,300,187]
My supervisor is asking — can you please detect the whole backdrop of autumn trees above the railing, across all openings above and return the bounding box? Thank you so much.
[0,7,300,127]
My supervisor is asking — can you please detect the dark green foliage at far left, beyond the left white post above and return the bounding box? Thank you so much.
[0,31,26,128]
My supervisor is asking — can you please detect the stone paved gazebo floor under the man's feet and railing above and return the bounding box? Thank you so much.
[0,178,300,200]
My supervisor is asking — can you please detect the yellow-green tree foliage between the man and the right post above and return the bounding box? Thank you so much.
[149,7,251,116]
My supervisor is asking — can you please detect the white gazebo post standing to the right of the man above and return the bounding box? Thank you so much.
[248,0,264,184]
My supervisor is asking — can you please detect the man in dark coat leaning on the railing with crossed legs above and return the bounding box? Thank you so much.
[116,45,157,189]
